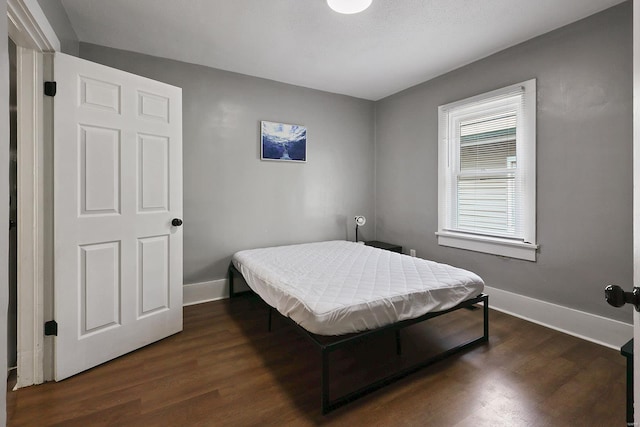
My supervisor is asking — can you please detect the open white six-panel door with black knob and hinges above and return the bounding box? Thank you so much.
[54,53,182,381]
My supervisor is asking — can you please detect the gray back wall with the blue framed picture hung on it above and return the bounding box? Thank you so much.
[80,43,375,283]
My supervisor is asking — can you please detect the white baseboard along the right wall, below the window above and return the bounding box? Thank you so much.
[484,286,633,350]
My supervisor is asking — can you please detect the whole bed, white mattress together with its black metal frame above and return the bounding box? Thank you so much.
[229,241,489,414]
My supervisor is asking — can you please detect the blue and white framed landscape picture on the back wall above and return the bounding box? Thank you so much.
[260,121,307,162]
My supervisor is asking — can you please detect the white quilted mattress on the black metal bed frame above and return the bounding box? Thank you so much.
[232,241,484,335]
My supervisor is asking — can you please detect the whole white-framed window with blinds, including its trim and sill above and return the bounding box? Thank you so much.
[436,79,538,261]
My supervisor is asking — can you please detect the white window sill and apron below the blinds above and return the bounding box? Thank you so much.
[436,231,538,262]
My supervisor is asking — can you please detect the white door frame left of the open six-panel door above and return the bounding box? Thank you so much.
[7,0,60,388]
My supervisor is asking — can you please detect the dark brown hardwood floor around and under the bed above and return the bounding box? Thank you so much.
[7,296,626,426]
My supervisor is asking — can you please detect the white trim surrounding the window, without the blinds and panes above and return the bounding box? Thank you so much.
[435,79,539,261]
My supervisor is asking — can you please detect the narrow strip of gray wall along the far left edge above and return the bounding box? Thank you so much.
[0,0,9,425]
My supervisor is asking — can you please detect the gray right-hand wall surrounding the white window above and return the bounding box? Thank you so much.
[376,2,633,322]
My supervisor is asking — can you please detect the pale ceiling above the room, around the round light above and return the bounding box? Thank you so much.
[62,0,622,100]
